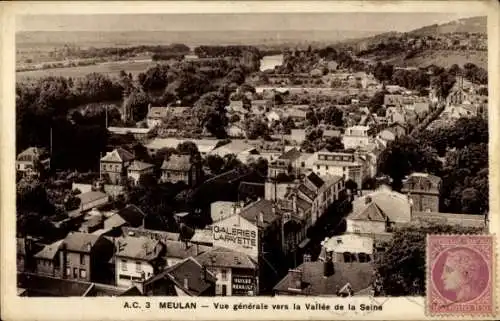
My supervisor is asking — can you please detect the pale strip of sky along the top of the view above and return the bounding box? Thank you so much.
[16,12,482,32]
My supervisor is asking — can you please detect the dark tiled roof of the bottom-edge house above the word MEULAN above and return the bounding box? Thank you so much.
[166,257,217,296]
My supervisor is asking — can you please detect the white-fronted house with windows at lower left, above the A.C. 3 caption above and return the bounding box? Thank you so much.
[115,236,166,287]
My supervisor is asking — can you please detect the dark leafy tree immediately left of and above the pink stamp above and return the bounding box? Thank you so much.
[375,225,484,296]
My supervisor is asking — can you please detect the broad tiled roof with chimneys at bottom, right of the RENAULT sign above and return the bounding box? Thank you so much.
[274,261,374,296]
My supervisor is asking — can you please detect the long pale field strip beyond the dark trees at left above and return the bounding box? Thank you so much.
[16,60,156,82]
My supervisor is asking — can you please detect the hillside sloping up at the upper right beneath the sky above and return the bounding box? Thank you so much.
[341,17,488,68]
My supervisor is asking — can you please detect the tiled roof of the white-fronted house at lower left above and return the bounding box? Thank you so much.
[115,236,164,261]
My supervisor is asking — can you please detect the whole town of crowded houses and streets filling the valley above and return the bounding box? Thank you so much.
[16,28,488,297]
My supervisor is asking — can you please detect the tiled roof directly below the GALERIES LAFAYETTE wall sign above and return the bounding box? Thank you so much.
[196,247,257,269]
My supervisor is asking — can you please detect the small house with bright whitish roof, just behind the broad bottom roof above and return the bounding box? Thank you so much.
[318,234,374,263]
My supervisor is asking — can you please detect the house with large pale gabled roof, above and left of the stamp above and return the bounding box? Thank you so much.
[346,185,412,234]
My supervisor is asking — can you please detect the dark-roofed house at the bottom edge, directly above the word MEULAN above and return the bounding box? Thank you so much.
[142,257,216,297]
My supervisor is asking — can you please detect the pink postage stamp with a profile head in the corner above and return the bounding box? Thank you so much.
[426,235,495,316]
